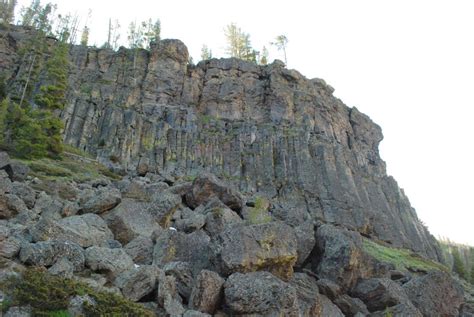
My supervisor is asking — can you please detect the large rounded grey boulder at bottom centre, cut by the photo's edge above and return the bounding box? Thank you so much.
[224,271,298,316]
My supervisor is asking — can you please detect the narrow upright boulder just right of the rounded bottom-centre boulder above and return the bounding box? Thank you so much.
[289,273,322,317]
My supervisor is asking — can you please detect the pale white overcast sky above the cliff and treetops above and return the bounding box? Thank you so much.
[14,0,474,246]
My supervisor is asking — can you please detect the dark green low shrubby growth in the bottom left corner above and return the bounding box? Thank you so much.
[1,268,154,317]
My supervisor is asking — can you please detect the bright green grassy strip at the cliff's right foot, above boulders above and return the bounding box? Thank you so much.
[363,239,449,272]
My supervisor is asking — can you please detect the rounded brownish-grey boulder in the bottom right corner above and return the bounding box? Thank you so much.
[403,271,464,316]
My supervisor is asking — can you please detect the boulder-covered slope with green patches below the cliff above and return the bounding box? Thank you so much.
[0,152,473,316]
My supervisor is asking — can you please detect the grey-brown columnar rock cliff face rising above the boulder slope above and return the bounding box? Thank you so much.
[0,24,439,259]
